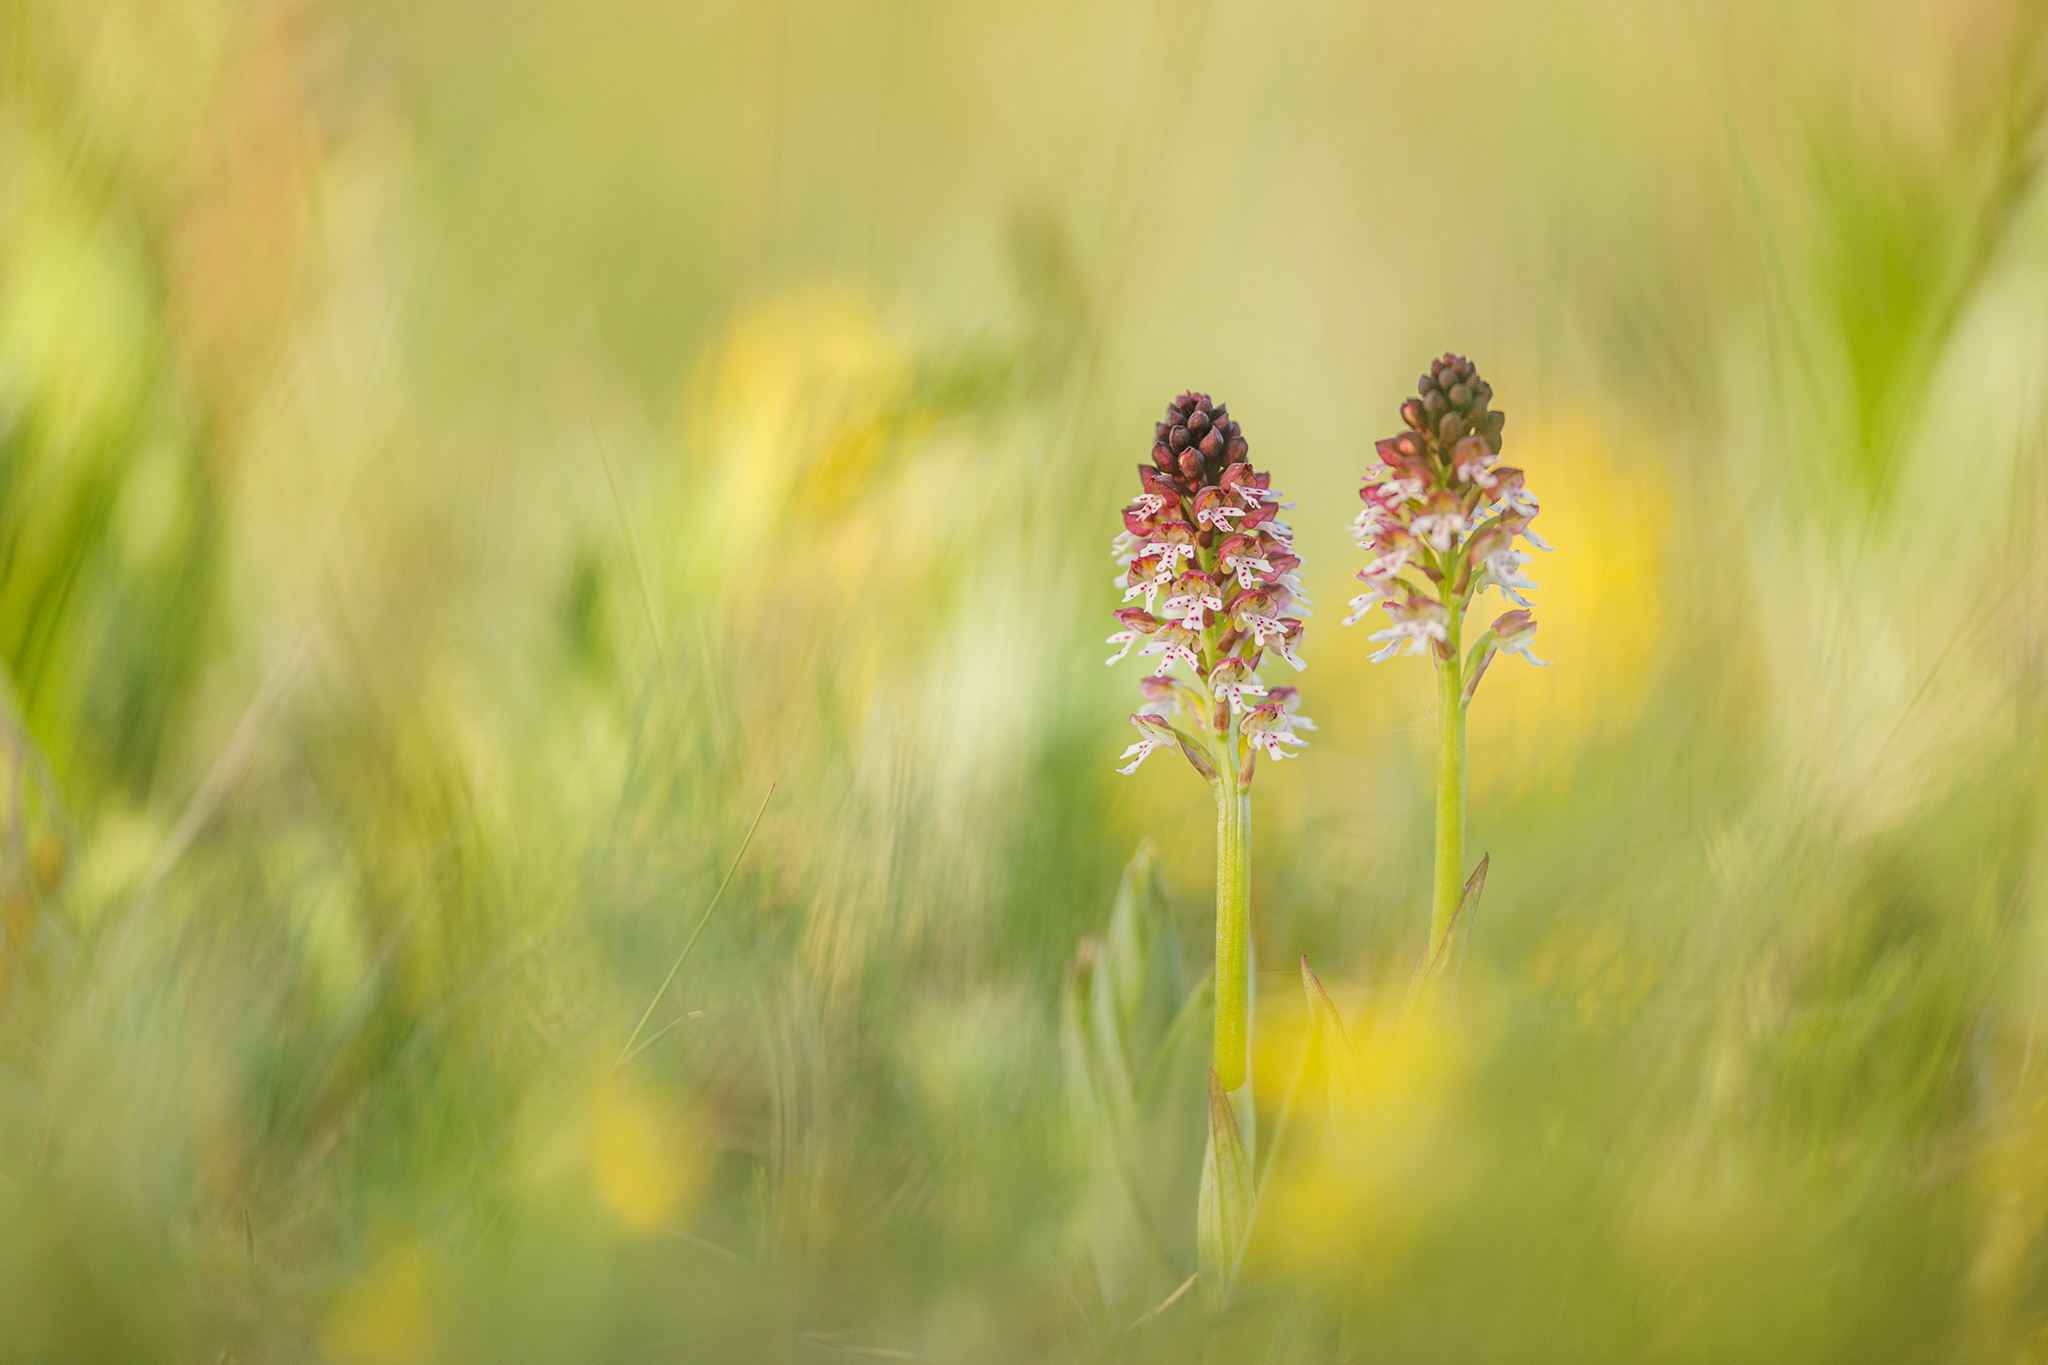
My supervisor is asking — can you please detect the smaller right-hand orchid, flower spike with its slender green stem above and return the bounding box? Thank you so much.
[1343,352,1550,960]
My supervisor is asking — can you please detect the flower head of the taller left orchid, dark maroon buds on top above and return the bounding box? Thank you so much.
[1108,393,1315,790]
